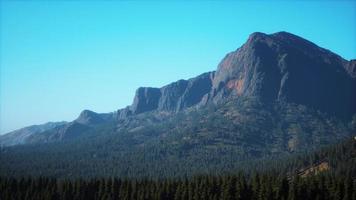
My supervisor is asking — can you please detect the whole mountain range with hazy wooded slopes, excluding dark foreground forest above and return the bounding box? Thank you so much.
[0,32,356,178]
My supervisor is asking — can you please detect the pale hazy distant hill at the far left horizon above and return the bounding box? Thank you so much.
[0,121,67,146]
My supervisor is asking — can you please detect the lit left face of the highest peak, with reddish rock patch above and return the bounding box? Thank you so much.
[211,33,279,102]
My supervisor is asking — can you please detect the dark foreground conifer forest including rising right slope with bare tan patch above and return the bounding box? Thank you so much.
[0,135,356,200]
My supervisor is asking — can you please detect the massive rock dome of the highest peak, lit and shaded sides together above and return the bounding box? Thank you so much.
[211,32,356,117]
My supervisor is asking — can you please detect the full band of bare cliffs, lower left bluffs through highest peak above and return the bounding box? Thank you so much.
[126,32,356,117]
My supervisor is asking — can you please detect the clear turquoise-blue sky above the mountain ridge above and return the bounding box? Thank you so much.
[0,0,356,133]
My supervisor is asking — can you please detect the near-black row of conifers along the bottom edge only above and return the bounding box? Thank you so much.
[0,174,356,200]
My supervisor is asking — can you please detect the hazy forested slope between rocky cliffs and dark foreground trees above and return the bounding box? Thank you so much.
[0,98,355,178]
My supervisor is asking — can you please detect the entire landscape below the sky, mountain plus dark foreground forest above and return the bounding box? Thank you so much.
[0,32,356,200]
